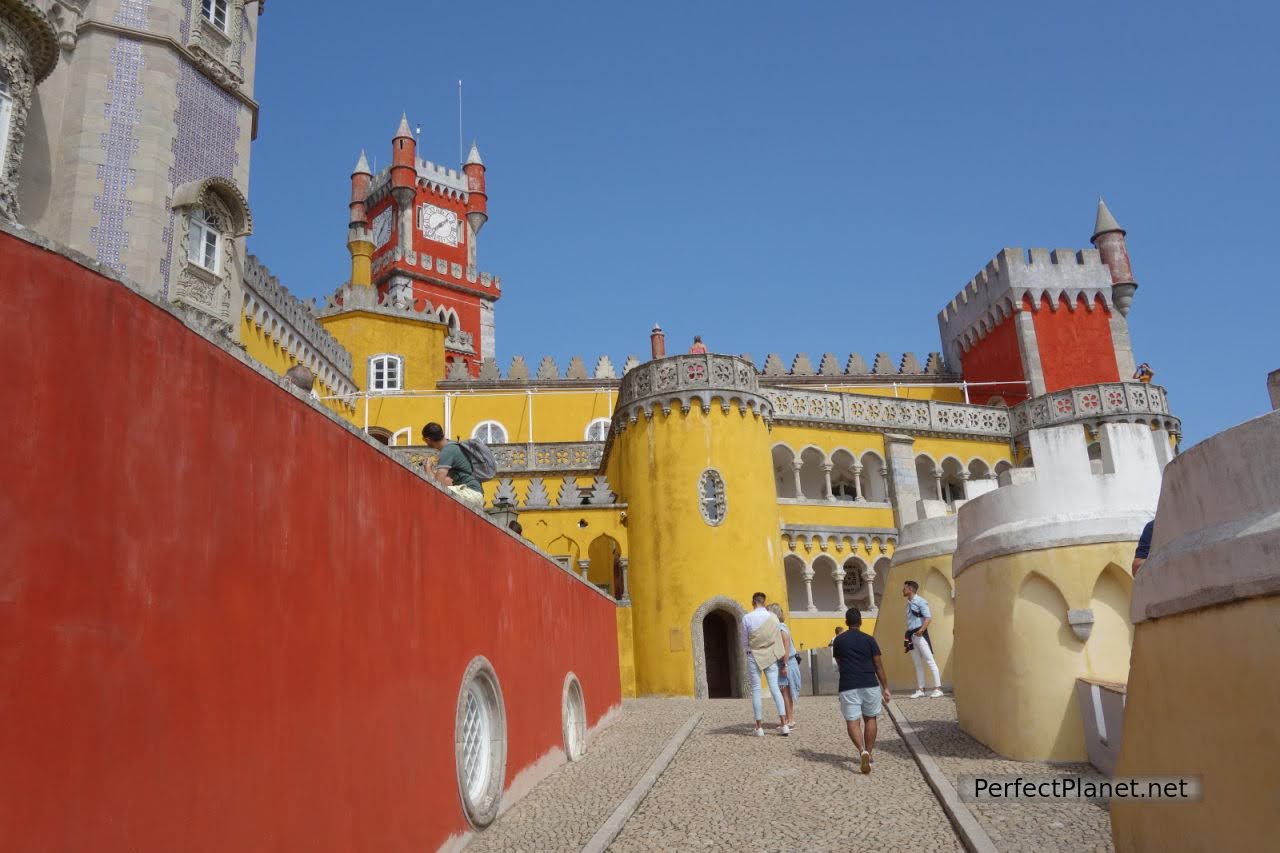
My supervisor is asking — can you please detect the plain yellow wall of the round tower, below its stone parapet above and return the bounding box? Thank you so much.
[614,406,786,695]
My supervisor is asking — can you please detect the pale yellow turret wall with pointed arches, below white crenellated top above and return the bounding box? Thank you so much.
[957,542,1134,761]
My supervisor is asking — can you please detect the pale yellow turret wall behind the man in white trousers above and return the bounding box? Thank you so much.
[876,553,957,690]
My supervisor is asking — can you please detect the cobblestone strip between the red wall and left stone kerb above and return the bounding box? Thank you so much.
[466,699,698,853]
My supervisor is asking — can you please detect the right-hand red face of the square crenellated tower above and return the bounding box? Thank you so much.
[1032,290,1120,391]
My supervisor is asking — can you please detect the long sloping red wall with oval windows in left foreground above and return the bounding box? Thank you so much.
[0,233,620,852]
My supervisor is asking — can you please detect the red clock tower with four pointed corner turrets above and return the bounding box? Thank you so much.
[348,117,502,377]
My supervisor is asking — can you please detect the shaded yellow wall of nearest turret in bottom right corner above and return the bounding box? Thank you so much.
[1111,596,1280,853]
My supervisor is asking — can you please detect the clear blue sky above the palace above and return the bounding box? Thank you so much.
[250,0,1280,448]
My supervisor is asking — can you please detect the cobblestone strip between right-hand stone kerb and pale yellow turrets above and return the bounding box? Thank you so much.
[893,697,1114,853]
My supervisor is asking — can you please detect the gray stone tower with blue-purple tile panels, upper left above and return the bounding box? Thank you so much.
[18,0,265,329]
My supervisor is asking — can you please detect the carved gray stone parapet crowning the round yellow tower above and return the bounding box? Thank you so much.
[613,353,773,432]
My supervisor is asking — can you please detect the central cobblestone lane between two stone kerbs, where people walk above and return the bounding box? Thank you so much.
[609,697,963,853]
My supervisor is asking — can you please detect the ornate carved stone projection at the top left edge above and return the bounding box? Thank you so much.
[0,0,58,220]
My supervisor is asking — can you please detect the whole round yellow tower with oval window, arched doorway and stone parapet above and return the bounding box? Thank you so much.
[609,355,786,697]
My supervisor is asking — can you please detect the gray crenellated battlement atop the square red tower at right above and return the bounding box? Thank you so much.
[938,248,1114,364]
